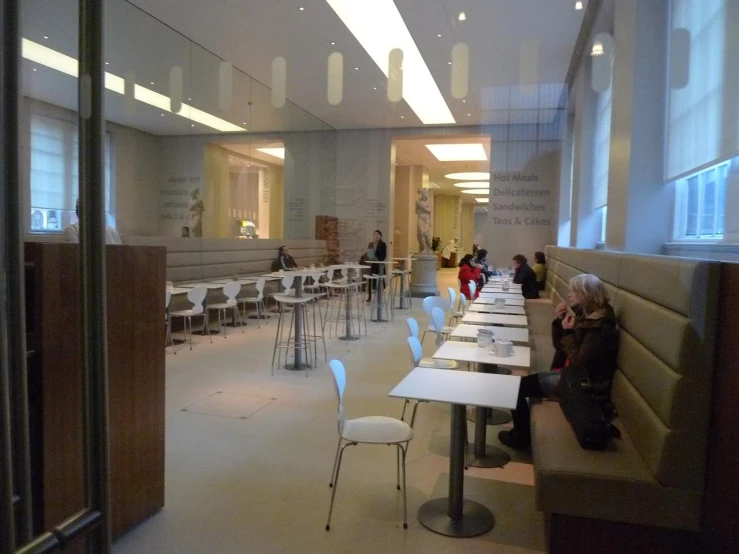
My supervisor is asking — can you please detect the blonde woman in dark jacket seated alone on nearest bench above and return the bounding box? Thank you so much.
[498,274,618,450]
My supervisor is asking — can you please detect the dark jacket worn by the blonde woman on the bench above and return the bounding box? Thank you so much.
[552,306,619,396]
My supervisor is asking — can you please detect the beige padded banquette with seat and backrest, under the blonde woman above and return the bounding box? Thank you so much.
[531,247,720,553]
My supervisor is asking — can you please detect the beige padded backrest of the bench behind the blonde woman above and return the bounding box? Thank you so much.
[546,246,720,491]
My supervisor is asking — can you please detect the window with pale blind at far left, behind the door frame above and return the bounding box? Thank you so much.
[30,114,115,232]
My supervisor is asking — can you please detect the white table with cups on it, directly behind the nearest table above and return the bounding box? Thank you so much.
[433,341,531,467]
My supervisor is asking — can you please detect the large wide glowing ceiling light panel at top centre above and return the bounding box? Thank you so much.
[326,0,456,125]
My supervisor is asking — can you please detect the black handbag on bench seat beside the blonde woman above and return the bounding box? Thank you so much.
[559,366,620,450]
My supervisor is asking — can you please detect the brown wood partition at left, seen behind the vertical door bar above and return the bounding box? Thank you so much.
[26,243,166,537]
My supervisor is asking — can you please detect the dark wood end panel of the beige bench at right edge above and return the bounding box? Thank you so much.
[702,263,739,552]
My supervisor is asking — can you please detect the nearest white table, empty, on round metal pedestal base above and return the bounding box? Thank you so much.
[389,367,521,537]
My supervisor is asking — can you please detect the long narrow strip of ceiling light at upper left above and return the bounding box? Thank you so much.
[22,38,244,133]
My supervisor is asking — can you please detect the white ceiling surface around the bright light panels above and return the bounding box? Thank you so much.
[23,0,583,134]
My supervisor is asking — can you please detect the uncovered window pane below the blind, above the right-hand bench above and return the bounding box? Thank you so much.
[675,162,730,239]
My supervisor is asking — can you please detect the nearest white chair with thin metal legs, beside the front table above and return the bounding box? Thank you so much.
[326,360,413,531]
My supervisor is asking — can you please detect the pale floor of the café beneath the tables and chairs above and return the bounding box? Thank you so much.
[114,270,544,554]
